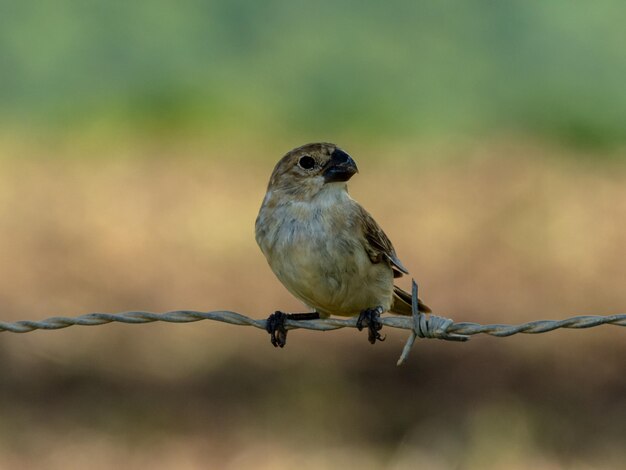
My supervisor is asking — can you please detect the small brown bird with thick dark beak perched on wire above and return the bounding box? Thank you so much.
[255,143,430,347]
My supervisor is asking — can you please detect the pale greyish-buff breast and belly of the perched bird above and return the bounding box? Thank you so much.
[257,197,393,315]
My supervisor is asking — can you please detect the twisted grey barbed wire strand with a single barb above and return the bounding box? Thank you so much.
[0,284,626,365]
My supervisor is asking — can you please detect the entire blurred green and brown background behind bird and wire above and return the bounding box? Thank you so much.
[0,0,626,469]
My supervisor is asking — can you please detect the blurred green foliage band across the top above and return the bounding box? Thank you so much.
[0,0,626,148]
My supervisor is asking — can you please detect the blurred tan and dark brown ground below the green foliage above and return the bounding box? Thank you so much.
[0,143,626,469]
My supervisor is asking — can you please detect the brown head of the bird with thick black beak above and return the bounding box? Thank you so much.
[268,143,359,200]
